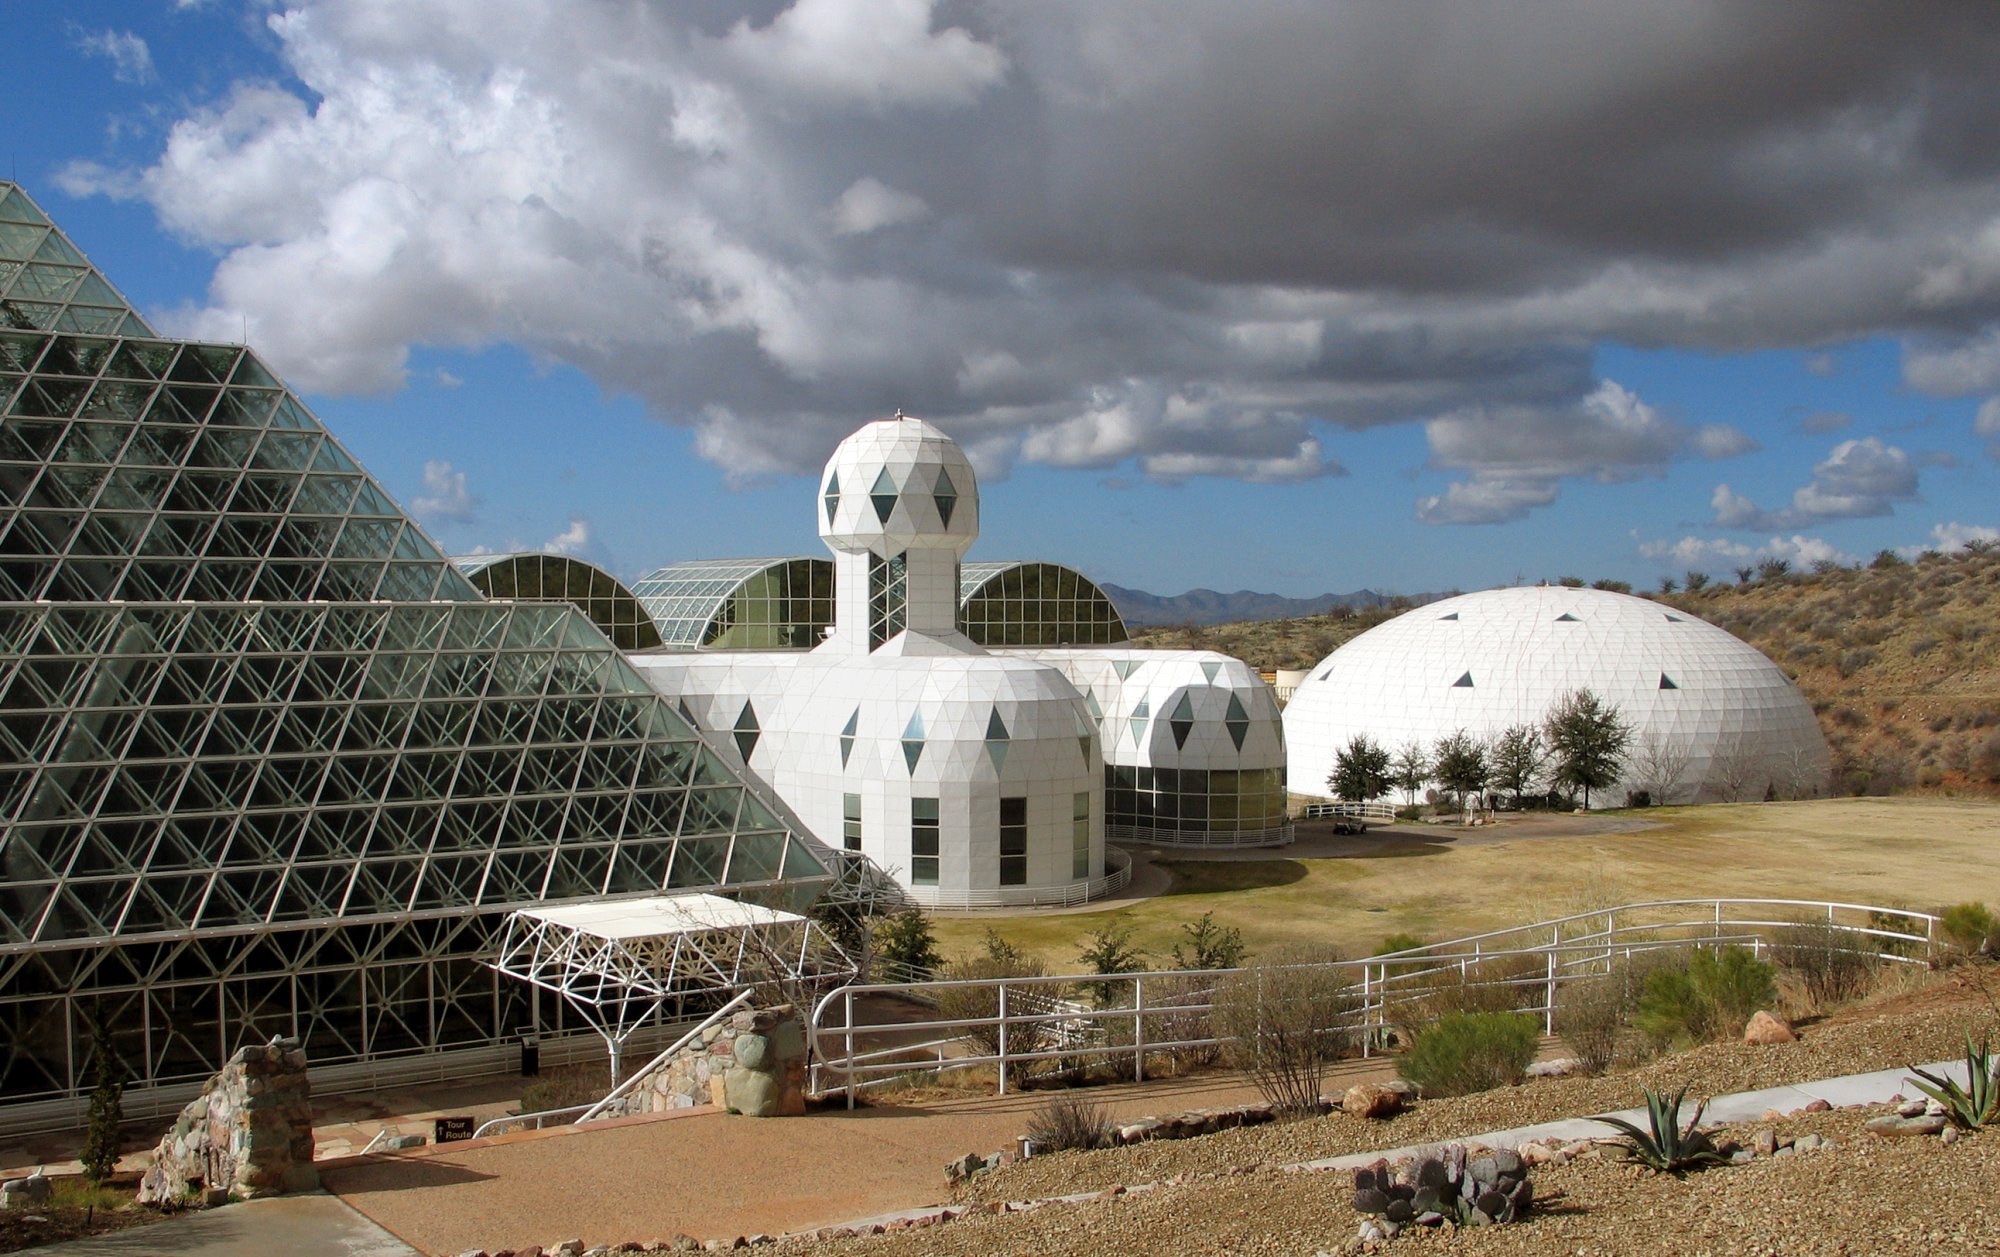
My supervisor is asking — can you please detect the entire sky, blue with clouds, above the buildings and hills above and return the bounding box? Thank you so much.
[0,0,2000,594]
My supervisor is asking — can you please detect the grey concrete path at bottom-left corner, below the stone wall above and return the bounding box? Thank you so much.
[36,1193,422,1257]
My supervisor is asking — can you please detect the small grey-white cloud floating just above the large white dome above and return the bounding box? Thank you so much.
[1416,380,1756,524]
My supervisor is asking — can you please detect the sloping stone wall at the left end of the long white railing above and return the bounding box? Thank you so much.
[620,1005,806,1117]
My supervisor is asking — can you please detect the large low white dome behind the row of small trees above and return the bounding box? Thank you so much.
[1284,586,1830,805]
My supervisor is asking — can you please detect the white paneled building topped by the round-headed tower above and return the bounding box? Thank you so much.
[632,416,1126,907]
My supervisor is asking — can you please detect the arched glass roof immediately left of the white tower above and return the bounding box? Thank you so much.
[634,558,834,651]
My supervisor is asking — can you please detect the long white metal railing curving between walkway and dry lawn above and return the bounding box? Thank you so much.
[808,899,1938,1107]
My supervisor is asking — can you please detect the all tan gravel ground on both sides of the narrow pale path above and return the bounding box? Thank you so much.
[782,975,2000,1257]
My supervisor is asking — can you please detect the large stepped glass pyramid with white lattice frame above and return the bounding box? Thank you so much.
[0,182,842,1103]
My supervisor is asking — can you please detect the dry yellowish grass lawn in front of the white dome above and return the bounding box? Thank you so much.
[936,797,2000,973]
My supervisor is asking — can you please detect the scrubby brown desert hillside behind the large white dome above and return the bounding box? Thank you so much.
[1134,542,2000,795]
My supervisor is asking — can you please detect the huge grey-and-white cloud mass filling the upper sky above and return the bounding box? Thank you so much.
[68,0,2000,510]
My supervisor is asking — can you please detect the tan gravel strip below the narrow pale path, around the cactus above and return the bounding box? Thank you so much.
[780,1111,2000,1257]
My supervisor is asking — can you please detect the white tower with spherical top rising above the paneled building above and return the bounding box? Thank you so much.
[818,410,980,655]
